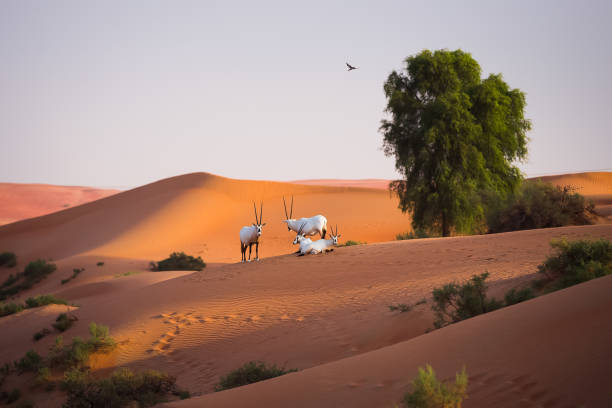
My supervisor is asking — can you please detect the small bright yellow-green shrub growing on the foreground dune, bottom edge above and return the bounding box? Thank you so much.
[403,364,468,408]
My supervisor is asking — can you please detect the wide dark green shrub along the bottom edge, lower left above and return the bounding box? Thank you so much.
[62,368,179,408]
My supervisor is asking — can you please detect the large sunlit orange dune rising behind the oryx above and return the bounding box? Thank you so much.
[0,173,411,262]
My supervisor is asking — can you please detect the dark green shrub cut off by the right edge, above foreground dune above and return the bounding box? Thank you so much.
[538,239,612,289]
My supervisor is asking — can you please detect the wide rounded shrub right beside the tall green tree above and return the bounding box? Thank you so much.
[487,180,597,233]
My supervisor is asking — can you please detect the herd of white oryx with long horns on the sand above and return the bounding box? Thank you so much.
[240,196,340,262]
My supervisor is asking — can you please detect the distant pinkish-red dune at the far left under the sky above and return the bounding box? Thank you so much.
[0,183,119,225]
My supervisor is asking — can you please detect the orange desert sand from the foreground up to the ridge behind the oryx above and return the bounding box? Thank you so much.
[0,173,612,407]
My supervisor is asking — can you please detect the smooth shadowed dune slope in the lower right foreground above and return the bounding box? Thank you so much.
[165,270,612,408]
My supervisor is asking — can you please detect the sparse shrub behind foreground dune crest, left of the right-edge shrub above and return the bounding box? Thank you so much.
[432,272,503,328]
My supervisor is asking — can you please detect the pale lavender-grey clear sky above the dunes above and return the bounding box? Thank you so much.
[0,0,612,188]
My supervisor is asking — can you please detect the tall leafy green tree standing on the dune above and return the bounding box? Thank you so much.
[380,50,531,236]
